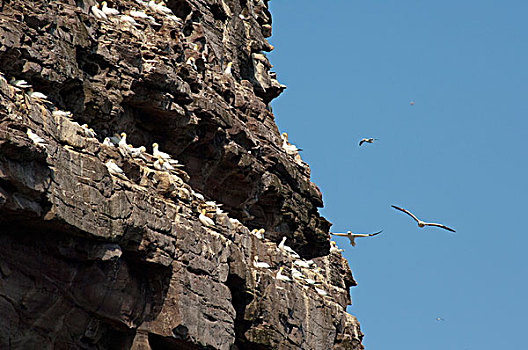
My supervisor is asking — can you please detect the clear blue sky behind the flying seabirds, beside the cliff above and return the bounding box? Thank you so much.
[269,0,528,350]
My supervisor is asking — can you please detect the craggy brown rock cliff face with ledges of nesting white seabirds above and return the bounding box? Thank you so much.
[0,0,363,349]
